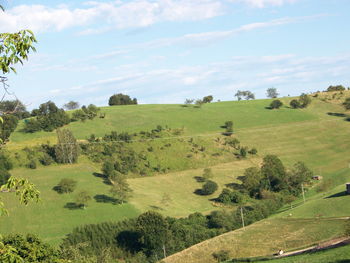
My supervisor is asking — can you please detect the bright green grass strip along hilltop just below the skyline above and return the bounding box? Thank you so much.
[9,100,317,147]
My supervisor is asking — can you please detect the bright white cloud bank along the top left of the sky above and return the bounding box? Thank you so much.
[0,0,224,34]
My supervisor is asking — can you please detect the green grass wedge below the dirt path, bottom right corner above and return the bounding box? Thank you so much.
[232,245,350,263]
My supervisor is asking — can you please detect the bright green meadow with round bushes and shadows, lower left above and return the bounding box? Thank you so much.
[0,164,139,248]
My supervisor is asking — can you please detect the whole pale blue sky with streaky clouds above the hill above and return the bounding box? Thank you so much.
[0,0,350,109]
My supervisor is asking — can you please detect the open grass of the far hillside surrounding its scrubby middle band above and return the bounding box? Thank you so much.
[0,96,350,248]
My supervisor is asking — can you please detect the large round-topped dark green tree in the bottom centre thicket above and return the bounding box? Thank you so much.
[136,211,169,257]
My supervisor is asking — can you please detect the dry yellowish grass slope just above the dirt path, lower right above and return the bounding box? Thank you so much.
[164,219,344,263]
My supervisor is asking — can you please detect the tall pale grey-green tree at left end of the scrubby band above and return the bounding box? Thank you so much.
[55,129,79,164]
